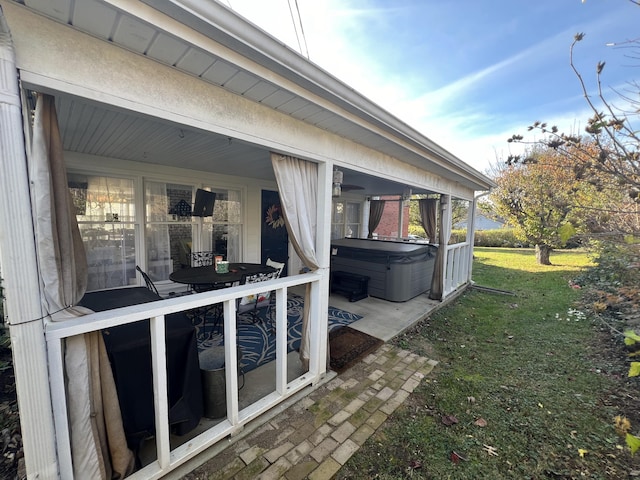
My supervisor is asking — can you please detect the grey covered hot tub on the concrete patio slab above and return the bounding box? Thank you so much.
[331,238,438,302]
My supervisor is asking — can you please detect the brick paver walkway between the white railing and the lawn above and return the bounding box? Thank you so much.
[185,345,437,480]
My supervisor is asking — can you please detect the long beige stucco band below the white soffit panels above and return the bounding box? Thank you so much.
[2,2,473,199]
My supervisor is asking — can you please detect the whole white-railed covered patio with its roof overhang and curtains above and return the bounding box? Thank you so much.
[0,0,493,478]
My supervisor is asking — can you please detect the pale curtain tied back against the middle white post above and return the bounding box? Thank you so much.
[271,153,320,368]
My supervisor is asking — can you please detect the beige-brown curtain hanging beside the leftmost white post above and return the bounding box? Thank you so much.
[29,95,134,479]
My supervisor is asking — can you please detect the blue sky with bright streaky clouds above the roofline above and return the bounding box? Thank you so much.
[222,0,640,172]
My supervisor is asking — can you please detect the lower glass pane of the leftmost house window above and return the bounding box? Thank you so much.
[79,223,136,291]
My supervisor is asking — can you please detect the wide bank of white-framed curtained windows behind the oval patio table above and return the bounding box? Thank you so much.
[67,173,242,291]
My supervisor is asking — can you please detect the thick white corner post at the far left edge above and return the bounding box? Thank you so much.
[0,10,60,478]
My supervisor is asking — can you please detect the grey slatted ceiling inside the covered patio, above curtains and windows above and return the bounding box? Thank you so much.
[51,94,429,195]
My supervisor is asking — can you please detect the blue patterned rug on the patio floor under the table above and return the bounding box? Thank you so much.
[196,293,362,373]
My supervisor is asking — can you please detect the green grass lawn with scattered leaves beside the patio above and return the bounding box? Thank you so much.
[336,248,640,480]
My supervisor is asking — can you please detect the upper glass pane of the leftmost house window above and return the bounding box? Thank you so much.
[68,174,135,222]
